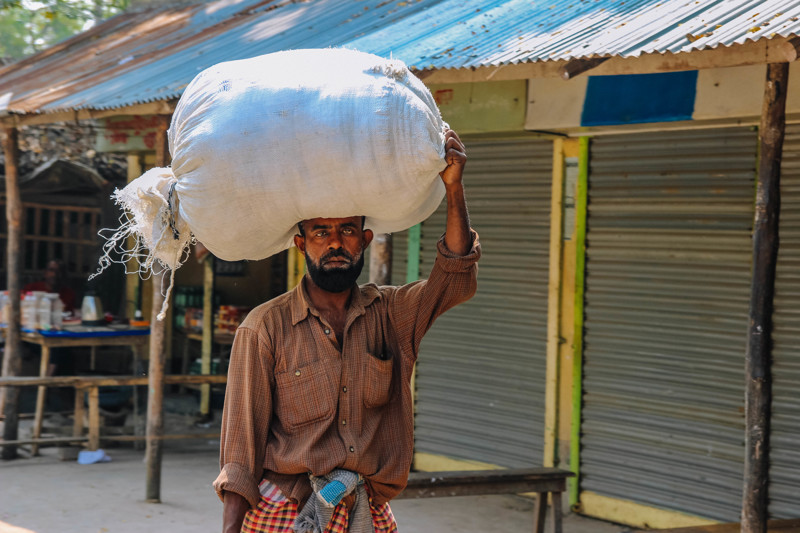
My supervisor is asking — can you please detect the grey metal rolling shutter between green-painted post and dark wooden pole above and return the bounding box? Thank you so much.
[580,128,757,521]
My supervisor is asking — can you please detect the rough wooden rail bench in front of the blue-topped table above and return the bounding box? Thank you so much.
[0,374,227,450]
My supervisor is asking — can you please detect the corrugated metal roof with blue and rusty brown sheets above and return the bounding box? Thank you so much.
[0,0,800,113]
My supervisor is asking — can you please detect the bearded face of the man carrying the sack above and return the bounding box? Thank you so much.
[294,216,372,292]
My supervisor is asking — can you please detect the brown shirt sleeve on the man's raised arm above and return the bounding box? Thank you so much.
[391,229,481,358]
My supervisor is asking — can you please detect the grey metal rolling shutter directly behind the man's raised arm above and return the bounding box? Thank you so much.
[416,138,552,467]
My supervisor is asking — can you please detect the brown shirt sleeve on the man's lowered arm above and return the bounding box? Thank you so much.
[214,327,274,507]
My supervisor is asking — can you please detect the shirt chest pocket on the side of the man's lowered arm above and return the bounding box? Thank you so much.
[274,361,336,429]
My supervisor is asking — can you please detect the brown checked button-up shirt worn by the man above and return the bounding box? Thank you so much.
[214,231,480,507]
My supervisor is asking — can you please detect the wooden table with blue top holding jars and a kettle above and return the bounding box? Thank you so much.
[17,326,150,455]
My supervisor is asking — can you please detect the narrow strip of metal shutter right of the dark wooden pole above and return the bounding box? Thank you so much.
[769,125,800,518]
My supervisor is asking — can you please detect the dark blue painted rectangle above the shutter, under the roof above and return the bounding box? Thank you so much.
[581,70,697,126]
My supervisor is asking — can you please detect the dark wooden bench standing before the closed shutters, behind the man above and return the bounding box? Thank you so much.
[395,468,574,533]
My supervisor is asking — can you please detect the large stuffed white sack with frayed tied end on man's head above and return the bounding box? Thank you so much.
[96,49,446,316]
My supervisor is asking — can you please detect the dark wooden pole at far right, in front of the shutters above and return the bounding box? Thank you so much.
[742,63,789,533]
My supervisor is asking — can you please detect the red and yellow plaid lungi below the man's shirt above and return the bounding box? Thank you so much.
[241,480,397,533]
